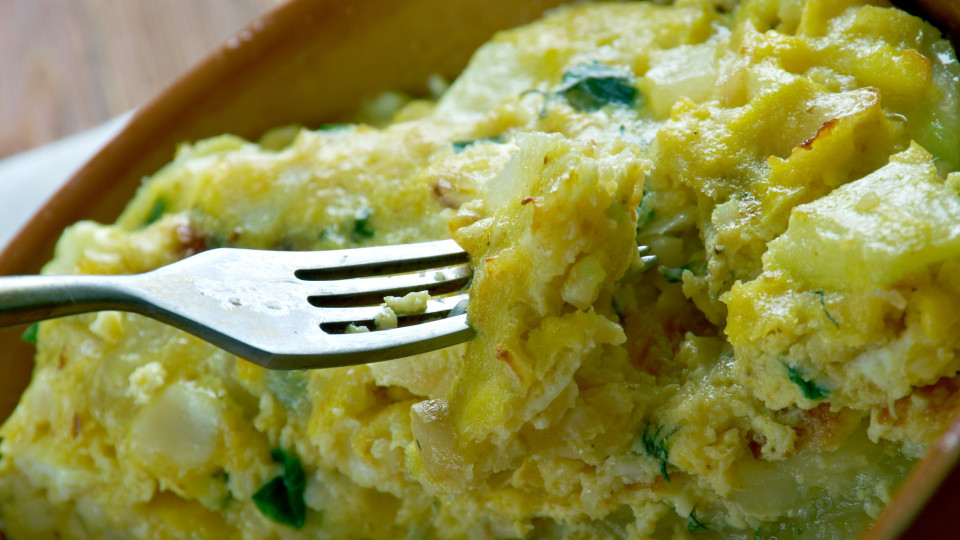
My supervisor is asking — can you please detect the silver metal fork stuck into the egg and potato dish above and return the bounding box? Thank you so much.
[0,240,656,369]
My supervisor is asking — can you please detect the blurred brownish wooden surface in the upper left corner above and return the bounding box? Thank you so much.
[0,0,282,158]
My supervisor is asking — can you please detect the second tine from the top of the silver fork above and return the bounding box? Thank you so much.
[307,264,473,308]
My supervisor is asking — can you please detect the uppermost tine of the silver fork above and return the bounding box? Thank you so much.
[295,240,469,281]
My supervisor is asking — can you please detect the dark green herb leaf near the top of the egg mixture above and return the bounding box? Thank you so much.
[556,60,637,112]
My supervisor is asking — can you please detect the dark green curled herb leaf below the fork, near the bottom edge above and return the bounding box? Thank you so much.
[253,448,307,529]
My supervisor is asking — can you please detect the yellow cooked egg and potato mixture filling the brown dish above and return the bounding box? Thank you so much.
[0,0,960,539]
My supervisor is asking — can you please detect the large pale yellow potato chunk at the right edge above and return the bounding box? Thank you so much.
[764,145,960,290]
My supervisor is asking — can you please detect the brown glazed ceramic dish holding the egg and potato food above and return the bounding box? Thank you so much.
[0,0,960,540]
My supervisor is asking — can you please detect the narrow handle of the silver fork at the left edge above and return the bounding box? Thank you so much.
[0,275,138,326]
